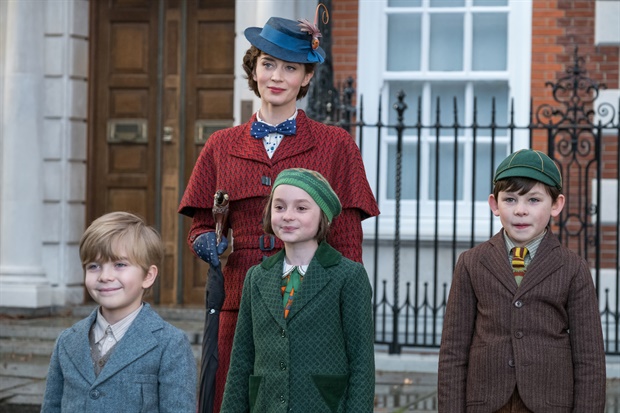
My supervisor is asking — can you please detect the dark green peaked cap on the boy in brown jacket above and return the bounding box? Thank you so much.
[493,149,562,190]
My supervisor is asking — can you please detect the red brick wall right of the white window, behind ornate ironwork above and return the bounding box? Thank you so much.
[531,0,620,268]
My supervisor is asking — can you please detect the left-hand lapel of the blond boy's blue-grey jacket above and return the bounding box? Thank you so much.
[63,307,99,384]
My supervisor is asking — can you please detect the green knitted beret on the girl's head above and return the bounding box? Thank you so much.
[271,168,342,222]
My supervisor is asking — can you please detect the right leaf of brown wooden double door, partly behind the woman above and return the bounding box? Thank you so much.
[183,0,235,303]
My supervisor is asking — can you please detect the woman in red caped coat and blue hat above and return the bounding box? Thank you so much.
[179,13,379,412]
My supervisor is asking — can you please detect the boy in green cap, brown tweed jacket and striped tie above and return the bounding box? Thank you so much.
[438,149,605,413]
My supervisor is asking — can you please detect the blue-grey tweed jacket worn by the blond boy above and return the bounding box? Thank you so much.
[41,303,197,413]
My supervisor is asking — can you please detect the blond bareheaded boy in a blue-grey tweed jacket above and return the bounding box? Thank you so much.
[41,212,196,413]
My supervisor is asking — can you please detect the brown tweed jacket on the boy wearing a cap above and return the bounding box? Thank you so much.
[438,229,605,413]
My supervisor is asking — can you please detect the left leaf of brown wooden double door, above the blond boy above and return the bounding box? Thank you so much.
[87,0,157,222]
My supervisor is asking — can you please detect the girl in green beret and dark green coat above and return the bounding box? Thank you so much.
[221,168,375,413]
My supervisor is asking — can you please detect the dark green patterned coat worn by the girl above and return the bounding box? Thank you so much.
[221,242,375,413]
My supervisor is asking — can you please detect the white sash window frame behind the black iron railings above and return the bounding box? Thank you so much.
[357,0,532,239]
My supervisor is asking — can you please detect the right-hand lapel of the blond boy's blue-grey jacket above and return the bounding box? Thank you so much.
[97,304,163,383]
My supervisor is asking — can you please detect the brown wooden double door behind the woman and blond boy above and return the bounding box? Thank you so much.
[86,0,235,306]
